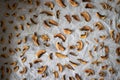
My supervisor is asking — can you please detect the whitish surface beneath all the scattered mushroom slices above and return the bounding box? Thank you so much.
[0,0,120,80]
